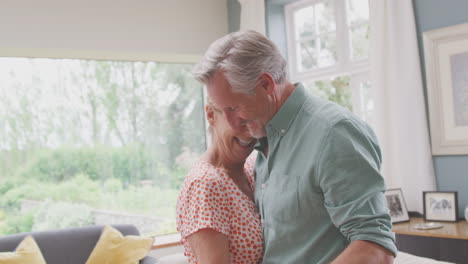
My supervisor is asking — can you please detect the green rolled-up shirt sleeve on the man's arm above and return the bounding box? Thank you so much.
[318,119,397,255]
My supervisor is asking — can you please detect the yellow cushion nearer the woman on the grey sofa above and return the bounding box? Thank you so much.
[86,225,153,264]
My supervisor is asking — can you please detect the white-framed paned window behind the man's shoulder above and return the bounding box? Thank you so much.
[285,0,373,122]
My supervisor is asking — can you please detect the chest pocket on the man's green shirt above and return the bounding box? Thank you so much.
[264,174,300,222]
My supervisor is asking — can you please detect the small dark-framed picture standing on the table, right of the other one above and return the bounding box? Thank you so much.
[423,191,458,222]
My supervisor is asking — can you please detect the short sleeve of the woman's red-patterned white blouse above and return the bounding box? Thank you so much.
[177,171,230,239]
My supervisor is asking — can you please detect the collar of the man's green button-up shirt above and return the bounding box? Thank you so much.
[267,83,307,135]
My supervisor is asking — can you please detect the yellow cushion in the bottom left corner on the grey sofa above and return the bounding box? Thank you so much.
[0,236,46,264]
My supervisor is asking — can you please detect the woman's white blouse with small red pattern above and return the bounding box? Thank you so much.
[177,159,263,264]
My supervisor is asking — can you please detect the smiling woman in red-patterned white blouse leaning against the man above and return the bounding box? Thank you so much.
[177,100,263,264]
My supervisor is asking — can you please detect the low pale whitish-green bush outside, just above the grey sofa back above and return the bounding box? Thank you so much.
[32,200,94,231]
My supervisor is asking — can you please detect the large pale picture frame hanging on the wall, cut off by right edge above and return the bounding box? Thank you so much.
[423,23,468,155]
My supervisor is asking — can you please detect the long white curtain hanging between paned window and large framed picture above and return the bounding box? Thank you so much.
[369,0,436,212]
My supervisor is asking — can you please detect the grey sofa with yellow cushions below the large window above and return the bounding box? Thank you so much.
[0,225,157,264]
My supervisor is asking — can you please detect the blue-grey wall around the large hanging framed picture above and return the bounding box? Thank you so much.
[413,0,468,217]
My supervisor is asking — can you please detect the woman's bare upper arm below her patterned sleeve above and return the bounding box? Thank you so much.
[187,228,230,264]
